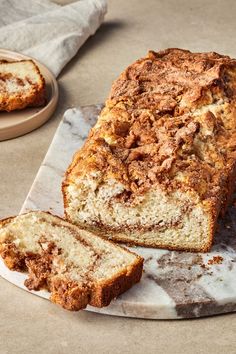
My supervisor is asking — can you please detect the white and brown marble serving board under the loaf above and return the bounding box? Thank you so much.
[0,105,236,319]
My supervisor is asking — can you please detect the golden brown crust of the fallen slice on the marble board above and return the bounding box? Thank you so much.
[0,212,143,311]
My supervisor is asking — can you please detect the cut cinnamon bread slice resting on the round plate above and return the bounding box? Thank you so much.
[0,60,46,112]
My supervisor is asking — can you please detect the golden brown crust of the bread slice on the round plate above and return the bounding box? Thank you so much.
[0,60,46,112]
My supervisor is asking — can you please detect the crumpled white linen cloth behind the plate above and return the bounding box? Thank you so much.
[0,0,107,76]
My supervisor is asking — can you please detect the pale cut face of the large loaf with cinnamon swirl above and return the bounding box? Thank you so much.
[64,186,213,250]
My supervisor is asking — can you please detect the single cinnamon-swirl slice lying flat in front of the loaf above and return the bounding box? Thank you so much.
[0,211,143,310]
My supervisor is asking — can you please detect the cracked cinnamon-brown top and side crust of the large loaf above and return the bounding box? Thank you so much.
[62,49,236,250]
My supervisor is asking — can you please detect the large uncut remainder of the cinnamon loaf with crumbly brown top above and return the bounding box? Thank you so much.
[62,49,236,252]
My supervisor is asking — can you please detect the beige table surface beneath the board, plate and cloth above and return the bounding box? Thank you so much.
[0,0,236,354]
